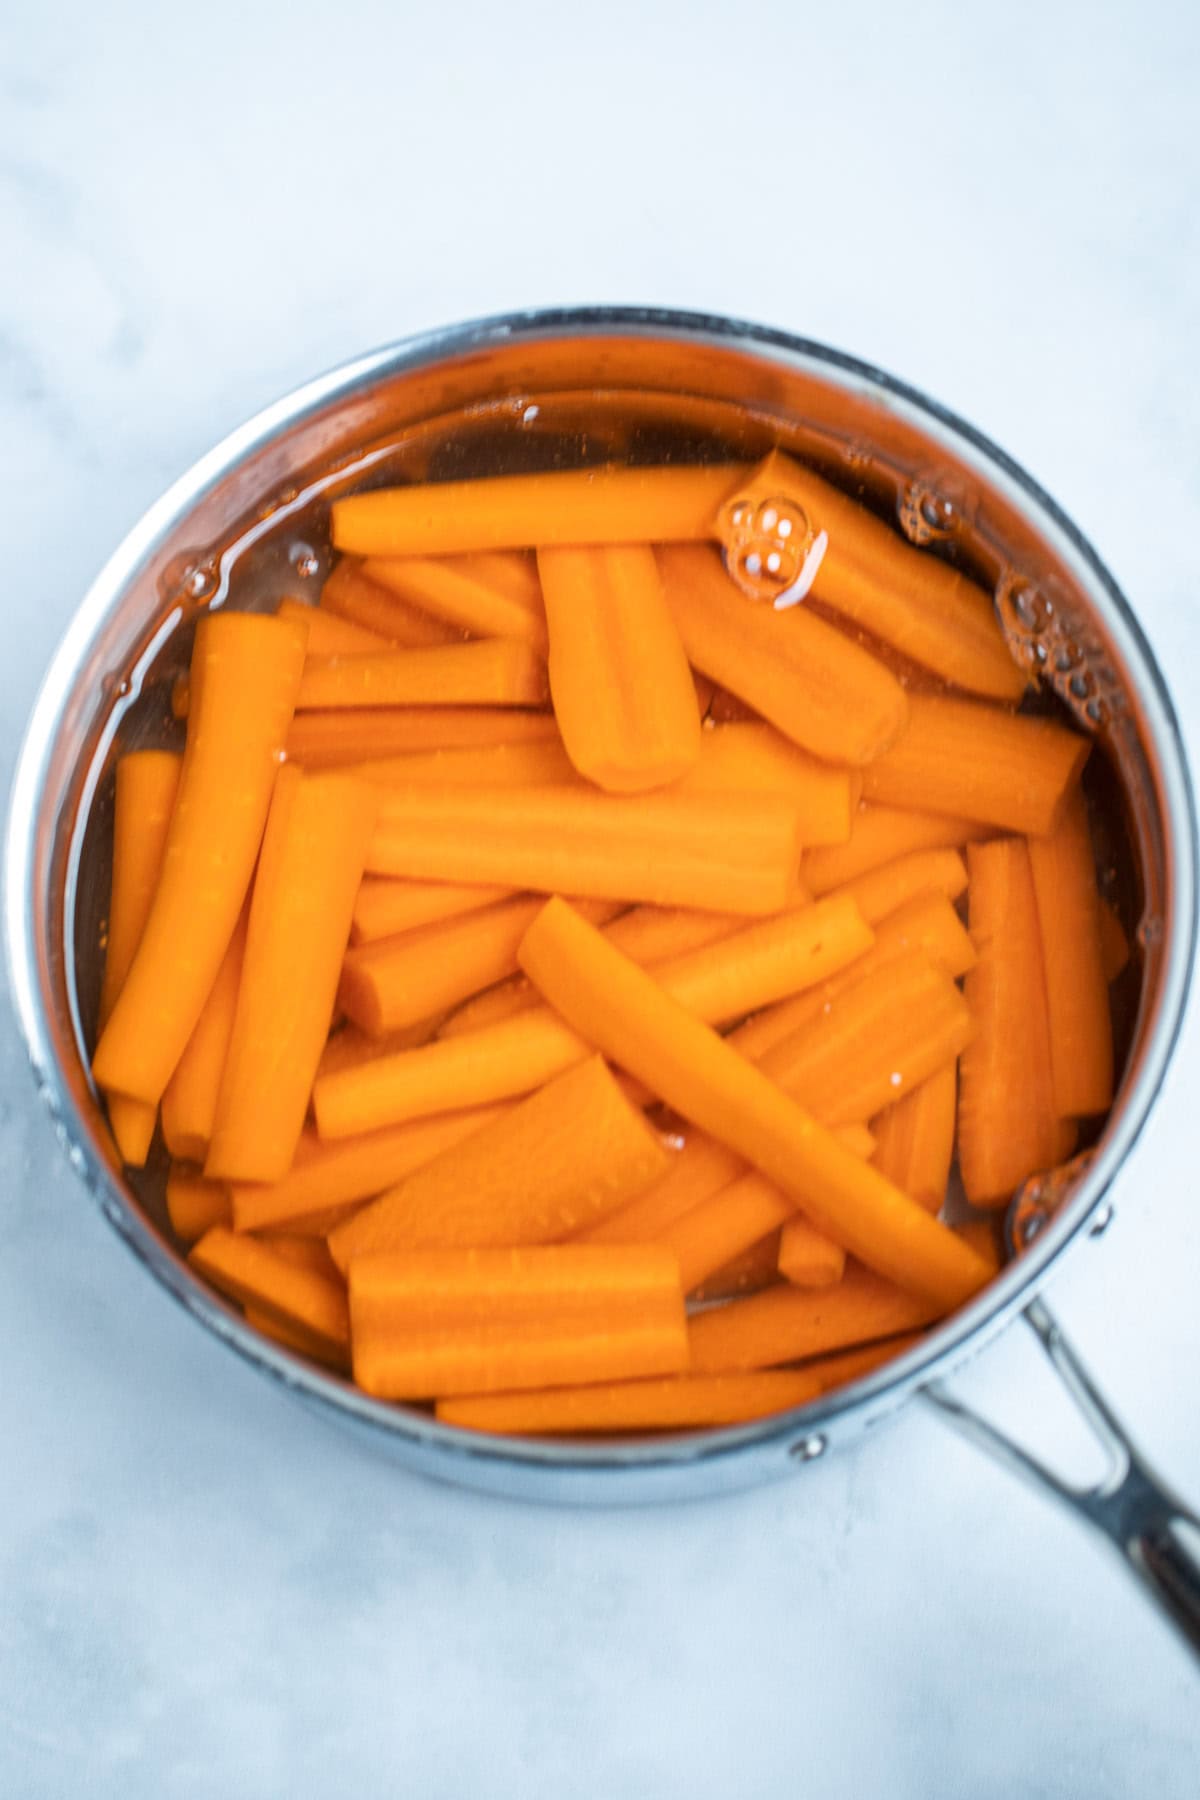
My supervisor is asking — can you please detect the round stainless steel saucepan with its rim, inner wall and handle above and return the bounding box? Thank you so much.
[5,310,1200,1649]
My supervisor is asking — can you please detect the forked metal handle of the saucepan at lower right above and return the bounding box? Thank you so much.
[923,1300,1200,1660]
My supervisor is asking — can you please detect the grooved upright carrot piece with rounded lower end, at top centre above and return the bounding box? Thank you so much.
[538,544,700,794]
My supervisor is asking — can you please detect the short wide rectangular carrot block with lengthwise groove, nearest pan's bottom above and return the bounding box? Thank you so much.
[351,1244,687,1400]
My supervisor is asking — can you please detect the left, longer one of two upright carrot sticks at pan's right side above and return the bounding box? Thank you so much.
[959,837,1060,1206]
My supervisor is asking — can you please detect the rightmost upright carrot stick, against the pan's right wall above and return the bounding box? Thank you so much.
[1029,788,1112,1118]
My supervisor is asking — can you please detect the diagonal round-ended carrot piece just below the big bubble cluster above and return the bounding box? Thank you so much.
[658,544,909,765]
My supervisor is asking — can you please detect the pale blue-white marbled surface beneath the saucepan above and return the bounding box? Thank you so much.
[0,0,1200,1800]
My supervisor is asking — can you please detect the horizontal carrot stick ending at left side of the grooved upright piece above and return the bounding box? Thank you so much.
[297,637,547,709]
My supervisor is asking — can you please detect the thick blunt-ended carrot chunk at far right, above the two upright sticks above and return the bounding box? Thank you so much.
[862,695,1090,837]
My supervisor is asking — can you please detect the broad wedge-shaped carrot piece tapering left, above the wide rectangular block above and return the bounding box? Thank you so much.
[329,1057,669,1269]
